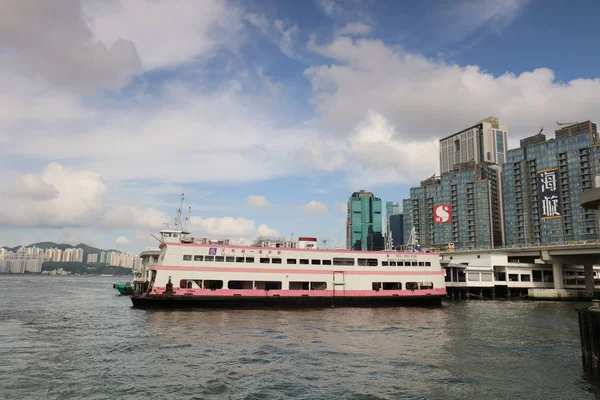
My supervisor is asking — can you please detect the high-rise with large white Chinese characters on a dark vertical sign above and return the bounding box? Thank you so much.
[503,121,600,246]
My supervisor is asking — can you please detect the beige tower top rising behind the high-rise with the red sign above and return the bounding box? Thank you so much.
[440,117,507,174]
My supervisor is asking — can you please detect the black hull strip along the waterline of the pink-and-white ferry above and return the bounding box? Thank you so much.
[131,294,442,309]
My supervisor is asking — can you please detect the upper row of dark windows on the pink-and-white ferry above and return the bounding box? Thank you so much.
[183,254,431,267]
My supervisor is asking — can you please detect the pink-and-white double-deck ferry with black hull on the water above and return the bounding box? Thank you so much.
[131,195,446,308]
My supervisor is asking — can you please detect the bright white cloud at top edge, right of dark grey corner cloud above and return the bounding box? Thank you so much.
[85,0,242,70]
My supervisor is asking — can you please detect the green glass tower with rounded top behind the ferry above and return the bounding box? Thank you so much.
[346,190,384,250]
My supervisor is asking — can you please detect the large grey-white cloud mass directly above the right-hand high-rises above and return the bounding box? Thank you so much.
[305,37,600,185]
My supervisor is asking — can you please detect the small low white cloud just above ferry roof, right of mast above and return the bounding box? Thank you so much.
[190,217,279,244]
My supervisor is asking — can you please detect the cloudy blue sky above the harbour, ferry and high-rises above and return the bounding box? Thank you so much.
[0,0,600,252]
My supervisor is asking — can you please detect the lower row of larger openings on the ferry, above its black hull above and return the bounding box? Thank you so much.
[179,279,433,292]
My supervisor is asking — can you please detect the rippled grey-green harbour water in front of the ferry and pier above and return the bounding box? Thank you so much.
[0,275,595,400]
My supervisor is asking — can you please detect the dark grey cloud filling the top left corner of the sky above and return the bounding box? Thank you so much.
[0,0,141,89]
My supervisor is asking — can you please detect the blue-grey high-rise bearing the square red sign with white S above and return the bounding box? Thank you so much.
[403,162,504,249]
